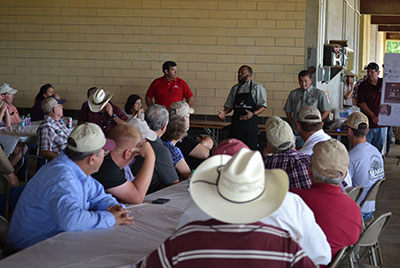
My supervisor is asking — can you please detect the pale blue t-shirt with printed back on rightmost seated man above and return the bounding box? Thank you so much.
[349,142,385,213]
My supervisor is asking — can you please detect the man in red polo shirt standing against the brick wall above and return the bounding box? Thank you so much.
[146,61,194,109]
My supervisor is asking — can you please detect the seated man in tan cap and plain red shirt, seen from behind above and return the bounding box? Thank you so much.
[291,139,362,259]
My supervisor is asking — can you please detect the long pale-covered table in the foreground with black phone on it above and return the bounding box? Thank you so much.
[0,181,190,268]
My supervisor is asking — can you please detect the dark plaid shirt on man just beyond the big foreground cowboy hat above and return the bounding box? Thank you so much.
[264,149,311,189]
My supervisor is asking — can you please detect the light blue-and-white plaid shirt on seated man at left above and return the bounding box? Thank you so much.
[38,115,72,154]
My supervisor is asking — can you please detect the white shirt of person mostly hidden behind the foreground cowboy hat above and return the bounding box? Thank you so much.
[177,192,332,265]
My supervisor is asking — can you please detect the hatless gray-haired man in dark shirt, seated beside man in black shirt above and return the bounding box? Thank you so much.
[132,104,179,194]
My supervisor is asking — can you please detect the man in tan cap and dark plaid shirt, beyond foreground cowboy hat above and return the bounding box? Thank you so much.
[264,116,311,188]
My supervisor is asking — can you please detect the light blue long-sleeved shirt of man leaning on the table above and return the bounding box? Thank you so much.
[7,154,118,250]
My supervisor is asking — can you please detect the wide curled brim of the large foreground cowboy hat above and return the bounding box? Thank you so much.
[190,155,289,224]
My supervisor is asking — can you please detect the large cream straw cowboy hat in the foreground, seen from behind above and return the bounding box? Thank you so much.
[190,149,289,224]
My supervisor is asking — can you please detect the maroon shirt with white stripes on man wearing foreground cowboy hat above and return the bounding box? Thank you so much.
[138,219,315,268]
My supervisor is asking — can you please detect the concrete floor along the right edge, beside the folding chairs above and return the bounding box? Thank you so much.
[375,144,400,268]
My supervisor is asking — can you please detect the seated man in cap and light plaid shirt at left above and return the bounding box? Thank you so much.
[38,97,71,160]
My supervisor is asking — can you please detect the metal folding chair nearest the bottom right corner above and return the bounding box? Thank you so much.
[336,212,392,268]
